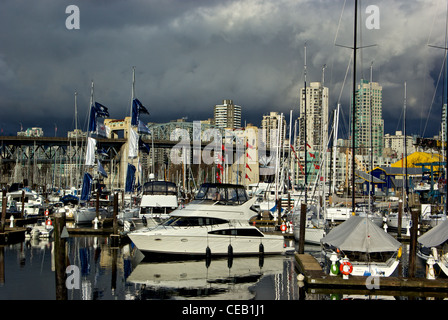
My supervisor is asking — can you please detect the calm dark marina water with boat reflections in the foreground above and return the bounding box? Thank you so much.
[0,232,440,300]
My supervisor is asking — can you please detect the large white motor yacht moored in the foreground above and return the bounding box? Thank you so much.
[128,183,286,256]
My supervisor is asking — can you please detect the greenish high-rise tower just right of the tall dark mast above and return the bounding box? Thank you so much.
[352,79,384,157]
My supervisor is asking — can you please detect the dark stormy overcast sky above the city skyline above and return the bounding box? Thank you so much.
[0,0,447,136]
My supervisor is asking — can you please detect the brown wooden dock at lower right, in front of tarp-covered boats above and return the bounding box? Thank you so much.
[295,253,448,297]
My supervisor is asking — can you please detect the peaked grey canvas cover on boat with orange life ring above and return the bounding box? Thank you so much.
[321,216,401,252]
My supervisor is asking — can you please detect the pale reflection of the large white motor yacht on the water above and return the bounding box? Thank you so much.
[127,255,291,300]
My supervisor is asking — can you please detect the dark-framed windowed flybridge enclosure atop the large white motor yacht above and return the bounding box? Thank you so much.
[193,183,249,205]
